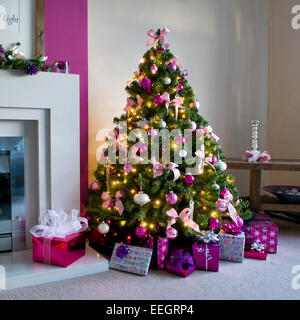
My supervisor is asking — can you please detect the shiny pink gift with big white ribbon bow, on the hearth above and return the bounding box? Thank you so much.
[30,209,88,267]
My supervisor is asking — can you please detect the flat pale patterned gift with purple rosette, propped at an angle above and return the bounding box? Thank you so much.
[109,243,152,276]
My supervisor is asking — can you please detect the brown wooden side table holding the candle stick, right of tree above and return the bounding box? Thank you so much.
[226,158,300,212]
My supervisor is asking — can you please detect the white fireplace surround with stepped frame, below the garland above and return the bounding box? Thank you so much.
[0,70,80,248]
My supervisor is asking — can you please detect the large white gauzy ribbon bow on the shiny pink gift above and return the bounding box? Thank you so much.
[30,209,88,238]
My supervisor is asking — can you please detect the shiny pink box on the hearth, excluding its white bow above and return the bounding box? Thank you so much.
[32,232,85,267]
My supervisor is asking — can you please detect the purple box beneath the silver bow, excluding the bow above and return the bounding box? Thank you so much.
[193,243,220,271]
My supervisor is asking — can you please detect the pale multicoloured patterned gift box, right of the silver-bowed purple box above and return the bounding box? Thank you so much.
[218,232,245,262]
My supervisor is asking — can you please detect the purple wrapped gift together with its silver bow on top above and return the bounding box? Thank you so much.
[192,231,220,271]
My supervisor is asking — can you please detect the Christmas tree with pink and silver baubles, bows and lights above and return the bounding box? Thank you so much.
[86,28,251,243]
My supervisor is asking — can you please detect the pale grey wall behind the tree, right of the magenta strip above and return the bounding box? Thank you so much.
[89,0,268,193]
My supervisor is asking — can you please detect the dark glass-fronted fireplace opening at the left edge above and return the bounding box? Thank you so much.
[0,137,25,252]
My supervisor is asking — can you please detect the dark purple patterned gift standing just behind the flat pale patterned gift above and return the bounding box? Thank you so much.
[149,236,170,270]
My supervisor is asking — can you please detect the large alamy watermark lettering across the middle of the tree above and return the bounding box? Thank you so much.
[96,121,214,175]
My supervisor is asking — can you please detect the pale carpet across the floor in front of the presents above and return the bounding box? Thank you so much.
[0,219,300,300]
